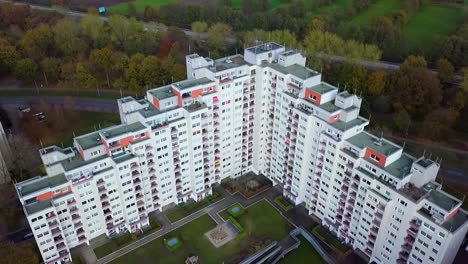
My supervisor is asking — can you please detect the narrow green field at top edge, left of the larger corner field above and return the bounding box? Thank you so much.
[346,0,403,26]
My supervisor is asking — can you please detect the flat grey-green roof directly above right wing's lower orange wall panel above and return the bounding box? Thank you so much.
[347,132,401,156]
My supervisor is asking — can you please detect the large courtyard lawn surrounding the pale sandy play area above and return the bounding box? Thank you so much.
[111,201,292,264]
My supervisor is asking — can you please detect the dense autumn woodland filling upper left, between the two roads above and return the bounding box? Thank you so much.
[0,4,185,91]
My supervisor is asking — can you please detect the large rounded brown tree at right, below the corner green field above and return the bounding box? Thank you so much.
[392,67,442,115]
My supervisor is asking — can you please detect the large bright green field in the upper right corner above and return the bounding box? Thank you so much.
[403,4,463,52]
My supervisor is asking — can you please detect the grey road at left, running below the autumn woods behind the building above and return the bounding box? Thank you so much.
[0,96,119,113]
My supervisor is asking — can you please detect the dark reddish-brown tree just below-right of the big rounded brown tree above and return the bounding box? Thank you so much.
[419,108,459,139]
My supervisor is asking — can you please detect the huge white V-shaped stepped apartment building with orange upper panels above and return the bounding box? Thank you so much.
[16,43,468,263]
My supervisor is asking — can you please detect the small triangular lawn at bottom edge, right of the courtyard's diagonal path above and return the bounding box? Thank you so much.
[279,235,326,264]
